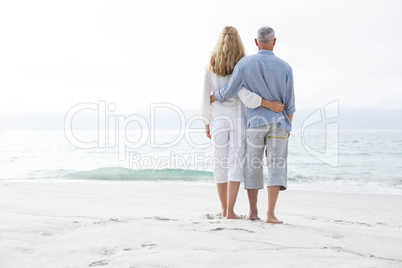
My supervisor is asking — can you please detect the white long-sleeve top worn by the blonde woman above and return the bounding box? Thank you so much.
[201,68,262,125]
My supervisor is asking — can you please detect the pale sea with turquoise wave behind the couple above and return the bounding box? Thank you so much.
[0,129,402,195]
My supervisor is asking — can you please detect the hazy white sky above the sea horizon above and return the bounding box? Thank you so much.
[0,0,402,127]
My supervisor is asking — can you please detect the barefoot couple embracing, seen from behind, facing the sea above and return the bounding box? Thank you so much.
[202,26,295,223]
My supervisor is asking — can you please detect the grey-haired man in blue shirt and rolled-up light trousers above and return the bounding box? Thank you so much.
[211,27,295,223]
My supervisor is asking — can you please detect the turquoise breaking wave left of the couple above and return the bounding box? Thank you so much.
[63,167,213,181]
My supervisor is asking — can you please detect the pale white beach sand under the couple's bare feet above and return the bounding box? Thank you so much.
[0,180,402,268]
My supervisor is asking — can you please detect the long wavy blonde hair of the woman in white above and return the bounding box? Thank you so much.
[209,26,246,76]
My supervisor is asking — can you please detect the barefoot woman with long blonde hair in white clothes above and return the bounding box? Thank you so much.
[202,26,284,219]
